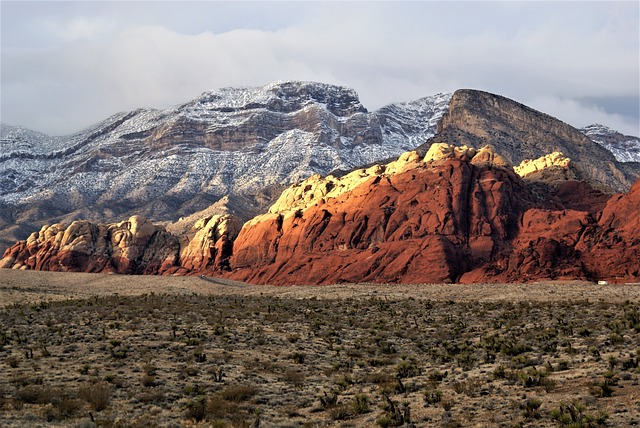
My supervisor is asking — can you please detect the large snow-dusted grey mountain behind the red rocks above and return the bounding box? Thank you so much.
[0,82,451,251]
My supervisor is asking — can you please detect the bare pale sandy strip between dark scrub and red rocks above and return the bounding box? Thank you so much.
[0,269,640,306]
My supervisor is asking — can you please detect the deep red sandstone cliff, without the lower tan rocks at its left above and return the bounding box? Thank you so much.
[219,144,640,284]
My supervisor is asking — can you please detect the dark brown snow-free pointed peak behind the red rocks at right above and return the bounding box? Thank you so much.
[425,90,640,193]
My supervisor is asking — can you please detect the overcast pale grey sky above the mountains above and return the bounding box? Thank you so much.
[0,0,640,136]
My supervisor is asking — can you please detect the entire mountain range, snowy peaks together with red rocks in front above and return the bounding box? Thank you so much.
[0,82,640,284]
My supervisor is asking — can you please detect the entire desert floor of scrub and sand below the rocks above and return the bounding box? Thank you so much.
[0,270,640,427]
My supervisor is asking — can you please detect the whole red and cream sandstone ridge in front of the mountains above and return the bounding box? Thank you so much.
[0,143,640,285]
